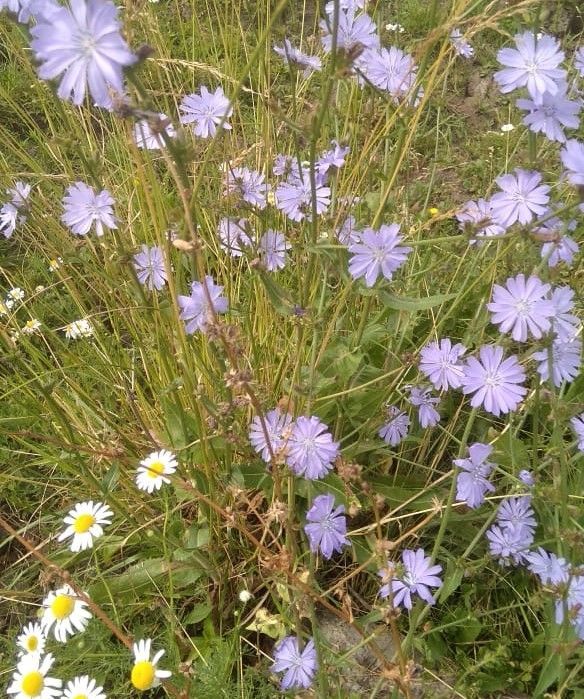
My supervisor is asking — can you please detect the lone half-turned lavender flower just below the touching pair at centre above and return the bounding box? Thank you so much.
[304,493,350,560]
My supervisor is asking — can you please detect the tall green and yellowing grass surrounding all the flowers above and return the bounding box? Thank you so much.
[0,0,584,699]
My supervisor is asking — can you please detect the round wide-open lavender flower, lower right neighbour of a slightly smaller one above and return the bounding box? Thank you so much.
[462,345,527,417]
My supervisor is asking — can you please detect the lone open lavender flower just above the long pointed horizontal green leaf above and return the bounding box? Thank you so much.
[349,223,412,287]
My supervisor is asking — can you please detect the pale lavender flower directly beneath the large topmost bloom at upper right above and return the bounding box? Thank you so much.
[516,82,582,143]
